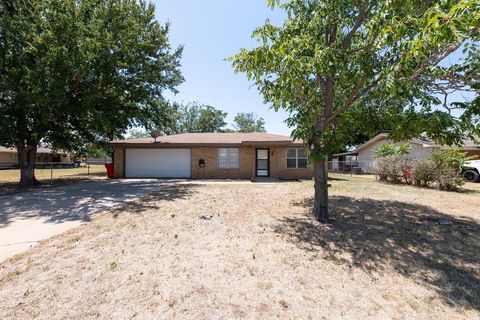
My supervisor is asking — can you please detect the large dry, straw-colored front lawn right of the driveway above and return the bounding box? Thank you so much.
[0,175,480,319]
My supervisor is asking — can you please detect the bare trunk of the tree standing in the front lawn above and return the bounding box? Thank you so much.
[313,160,329,223]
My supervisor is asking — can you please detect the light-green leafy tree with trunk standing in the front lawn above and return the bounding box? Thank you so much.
[230,0,480,222]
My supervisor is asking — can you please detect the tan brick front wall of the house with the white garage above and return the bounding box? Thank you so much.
[114,146,313,179]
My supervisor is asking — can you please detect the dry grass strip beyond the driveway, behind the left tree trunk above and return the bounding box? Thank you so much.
[0,165,106,194]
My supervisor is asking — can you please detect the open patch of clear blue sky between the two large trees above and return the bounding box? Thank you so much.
[154,0,291,135]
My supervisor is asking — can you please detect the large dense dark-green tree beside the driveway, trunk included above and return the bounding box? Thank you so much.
[0,0,183,185]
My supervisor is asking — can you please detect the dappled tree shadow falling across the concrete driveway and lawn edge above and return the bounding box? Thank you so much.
[0,180,197,225]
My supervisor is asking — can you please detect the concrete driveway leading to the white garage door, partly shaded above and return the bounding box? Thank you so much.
[0,180,169,262]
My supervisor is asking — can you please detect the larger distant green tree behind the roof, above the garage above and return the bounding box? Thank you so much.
[174,102,227,133]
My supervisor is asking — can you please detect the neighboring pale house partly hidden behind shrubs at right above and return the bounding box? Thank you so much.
[332,133,480,172]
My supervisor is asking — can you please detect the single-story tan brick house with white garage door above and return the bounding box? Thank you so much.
[110,133,313,179]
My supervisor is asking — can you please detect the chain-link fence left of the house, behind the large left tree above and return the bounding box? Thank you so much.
[0,159,111,182]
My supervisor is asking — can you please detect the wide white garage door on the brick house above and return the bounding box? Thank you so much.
[125,149,191,178]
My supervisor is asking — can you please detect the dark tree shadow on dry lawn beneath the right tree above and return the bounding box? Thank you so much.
[275,196,480,310]
